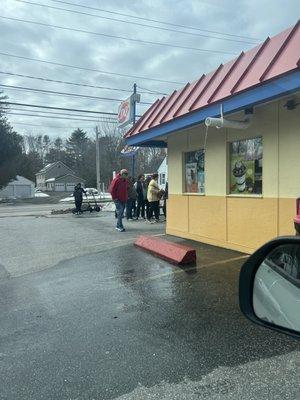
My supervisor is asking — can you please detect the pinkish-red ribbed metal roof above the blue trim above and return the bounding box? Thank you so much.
[126,21,300,138]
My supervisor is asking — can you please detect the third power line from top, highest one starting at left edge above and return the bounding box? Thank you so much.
[0,15,236,55]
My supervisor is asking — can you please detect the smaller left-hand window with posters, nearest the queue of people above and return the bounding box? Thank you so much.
[184,150,205,193]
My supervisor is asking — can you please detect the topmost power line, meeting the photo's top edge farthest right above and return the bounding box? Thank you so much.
[50,0,261,41]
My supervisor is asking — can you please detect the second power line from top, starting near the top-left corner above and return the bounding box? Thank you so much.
[15,0,257,45]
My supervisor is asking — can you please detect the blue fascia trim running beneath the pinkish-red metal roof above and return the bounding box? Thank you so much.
[126,71,300,147]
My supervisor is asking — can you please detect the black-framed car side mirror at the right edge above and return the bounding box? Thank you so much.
[239,236,300,338]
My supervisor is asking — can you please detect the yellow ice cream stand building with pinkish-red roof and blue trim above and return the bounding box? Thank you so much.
[126,22,300,253]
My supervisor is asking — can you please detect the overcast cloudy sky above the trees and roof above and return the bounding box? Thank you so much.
[0,0,300,137]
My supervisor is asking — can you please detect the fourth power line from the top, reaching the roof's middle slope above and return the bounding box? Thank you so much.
[0,51,184,85]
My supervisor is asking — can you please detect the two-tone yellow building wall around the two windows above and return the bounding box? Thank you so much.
[167,99,300,253]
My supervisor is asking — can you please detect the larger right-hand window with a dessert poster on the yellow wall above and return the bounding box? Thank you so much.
[230,137,263,194]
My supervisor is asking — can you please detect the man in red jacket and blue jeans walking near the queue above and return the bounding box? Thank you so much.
[109,169,128,232]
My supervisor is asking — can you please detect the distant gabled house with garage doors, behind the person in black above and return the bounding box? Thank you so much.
[36,161,85,192]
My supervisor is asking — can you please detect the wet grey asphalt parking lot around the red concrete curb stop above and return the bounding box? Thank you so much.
[0,206,300,400]
